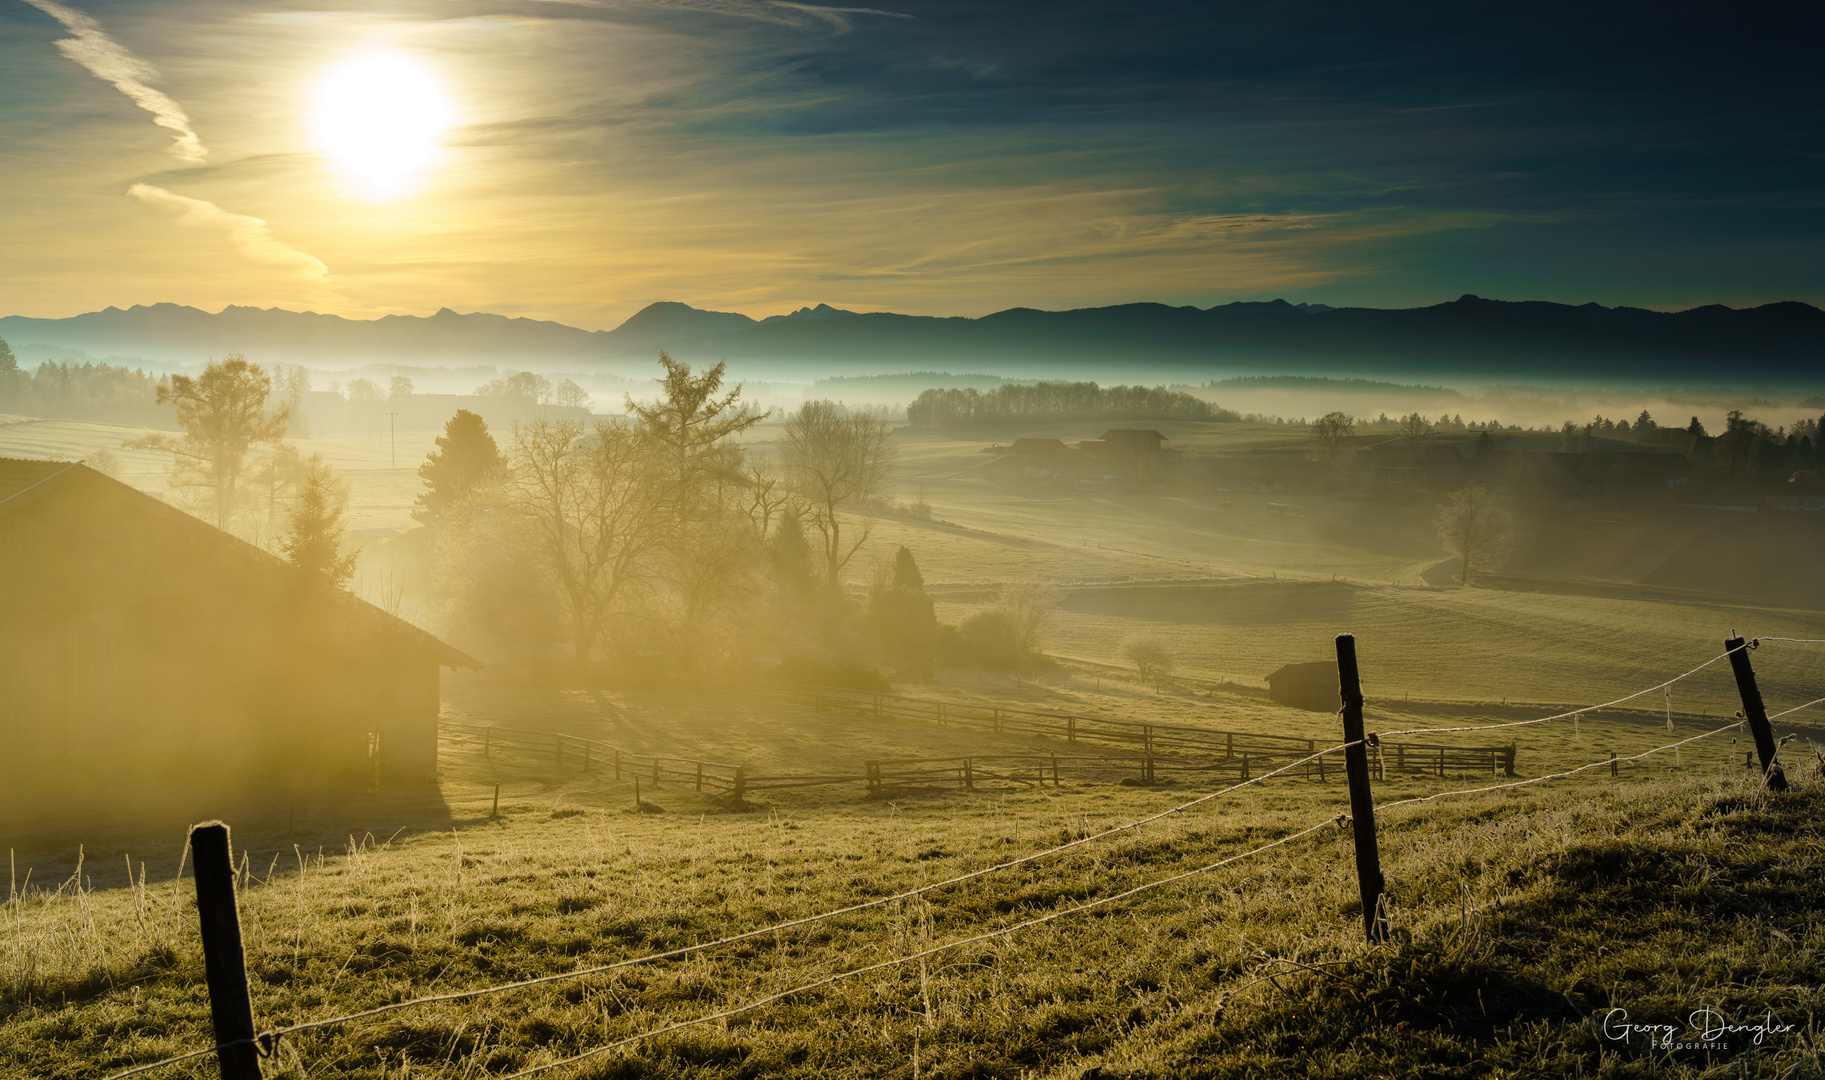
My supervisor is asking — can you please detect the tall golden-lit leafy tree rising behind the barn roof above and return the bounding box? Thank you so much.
[128,352,290,531]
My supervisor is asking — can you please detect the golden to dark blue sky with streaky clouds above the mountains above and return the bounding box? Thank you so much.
[0,0,1825,328]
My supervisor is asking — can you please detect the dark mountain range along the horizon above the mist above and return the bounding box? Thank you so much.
[0,296,1825,385]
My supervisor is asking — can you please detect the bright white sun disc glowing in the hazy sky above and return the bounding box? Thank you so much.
[314,53,456,199]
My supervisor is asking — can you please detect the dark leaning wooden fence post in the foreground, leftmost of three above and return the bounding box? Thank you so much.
[190,821,259,1080]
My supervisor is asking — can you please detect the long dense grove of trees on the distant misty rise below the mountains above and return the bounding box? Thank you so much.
[907,383,1241,429]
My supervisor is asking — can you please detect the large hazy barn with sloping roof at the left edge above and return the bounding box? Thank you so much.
[0,460,480,792]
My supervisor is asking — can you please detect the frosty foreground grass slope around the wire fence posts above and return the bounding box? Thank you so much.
[0,721,1825,1078]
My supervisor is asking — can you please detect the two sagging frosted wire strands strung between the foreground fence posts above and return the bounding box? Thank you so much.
[92,639,1825,1080]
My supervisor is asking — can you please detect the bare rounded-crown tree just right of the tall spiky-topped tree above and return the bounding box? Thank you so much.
[779,401,894,586]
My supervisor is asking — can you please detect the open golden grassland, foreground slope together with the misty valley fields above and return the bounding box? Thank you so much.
[0,408,1825,1080]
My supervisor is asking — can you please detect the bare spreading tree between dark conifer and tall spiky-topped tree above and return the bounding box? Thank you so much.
[507,420,672,664]
